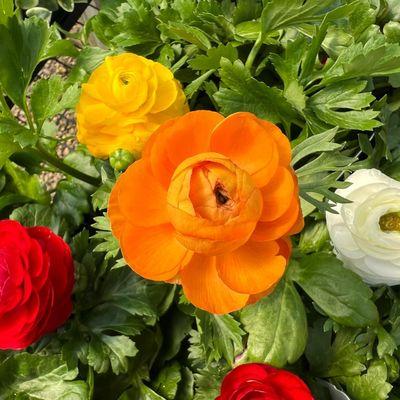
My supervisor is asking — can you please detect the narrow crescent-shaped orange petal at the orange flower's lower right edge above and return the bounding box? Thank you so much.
[251,195,301,241]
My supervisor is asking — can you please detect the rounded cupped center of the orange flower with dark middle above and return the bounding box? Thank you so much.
[167,153,262,255]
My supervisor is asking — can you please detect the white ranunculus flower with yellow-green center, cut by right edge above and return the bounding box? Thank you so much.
[326,169,400,285]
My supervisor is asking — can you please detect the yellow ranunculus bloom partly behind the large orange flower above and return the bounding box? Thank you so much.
[77,53,189,158]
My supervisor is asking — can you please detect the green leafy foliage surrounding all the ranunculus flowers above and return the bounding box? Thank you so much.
[0,0,400,400]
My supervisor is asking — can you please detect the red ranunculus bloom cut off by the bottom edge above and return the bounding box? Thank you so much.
[216,364,314,400]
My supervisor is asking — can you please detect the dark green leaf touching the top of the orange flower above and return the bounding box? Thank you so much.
[214,59,297,124]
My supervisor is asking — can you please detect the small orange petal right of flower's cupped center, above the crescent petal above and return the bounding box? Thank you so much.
[260,167,295,221]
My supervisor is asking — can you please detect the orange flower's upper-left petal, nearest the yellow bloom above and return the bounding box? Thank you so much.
[150,110,224,188]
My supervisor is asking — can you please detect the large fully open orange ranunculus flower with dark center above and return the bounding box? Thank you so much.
[108,111,303,314]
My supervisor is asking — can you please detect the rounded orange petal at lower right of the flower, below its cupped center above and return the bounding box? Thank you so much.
[217,241,286,294]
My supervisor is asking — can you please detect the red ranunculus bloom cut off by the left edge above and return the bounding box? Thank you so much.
[0,220,74,350]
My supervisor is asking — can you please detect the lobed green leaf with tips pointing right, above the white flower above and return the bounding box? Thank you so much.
[307,80,382,131]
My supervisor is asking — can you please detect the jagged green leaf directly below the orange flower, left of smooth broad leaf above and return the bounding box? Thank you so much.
[195,310,244,365]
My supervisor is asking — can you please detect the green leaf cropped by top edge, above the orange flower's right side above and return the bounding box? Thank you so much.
[261,0,332,35]
